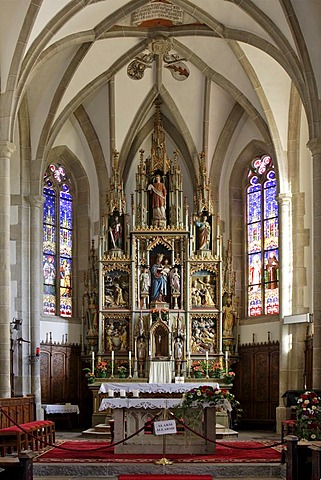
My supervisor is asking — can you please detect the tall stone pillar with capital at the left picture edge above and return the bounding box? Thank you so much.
[0,142,15,398]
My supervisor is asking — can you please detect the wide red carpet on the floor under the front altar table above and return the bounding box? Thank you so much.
[34,440,282,464]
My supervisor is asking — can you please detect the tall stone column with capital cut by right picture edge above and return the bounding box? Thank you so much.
[307,138,321,390]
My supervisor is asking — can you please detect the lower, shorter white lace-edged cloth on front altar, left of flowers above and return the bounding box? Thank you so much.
[99,398,182,412]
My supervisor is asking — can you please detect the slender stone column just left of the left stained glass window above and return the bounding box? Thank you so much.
[29,195,43,419]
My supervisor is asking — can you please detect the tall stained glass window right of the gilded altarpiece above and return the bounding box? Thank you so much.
[247,155,279,317]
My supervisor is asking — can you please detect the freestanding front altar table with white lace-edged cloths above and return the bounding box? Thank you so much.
[99,382,217,455]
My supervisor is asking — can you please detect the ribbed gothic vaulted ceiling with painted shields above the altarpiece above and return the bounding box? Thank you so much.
[0,0,321,216]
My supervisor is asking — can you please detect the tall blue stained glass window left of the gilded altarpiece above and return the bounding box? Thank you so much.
[42,163,73,317]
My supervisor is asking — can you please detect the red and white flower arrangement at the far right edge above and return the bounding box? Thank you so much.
[294,391,321,440]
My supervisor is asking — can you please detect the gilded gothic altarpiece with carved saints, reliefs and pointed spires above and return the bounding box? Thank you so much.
[82,101,237,383]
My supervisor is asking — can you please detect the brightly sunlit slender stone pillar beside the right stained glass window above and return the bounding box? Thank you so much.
[276,193,292,433]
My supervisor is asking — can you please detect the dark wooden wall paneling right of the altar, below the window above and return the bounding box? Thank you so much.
[233,342,279,426]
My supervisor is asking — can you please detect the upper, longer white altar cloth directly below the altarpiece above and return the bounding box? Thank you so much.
[98,382,219,394]
